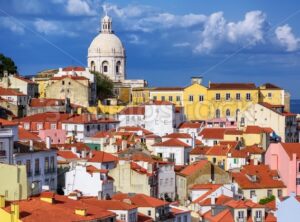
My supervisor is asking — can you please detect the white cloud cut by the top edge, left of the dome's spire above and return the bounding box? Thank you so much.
[66,0,96,15]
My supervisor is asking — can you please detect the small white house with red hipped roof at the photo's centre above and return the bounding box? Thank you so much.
[152,139,192,165]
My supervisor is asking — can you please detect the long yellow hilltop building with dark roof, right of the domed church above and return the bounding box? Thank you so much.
[132,77,289,120]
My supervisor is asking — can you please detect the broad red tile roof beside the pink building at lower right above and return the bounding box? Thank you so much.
[232,164,286,189]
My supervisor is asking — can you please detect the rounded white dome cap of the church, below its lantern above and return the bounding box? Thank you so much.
[89,33,125,56]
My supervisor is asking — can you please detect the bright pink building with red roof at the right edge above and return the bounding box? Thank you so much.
[265,143,300,195]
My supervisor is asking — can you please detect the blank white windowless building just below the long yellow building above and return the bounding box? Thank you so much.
[145,101,176,136]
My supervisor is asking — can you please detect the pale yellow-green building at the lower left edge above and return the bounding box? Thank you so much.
[0,164,28,201]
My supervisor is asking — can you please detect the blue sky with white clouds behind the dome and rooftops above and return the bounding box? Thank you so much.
[0,0,300,99]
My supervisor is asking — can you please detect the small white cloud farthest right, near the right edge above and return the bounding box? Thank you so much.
[275,24,300,52]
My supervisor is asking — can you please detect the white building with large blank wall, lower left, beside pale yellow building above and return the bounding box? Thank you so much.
[64,162,113,199]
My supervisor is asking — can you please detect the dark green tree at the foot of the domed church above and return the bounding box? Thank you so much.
[92,71,114,101]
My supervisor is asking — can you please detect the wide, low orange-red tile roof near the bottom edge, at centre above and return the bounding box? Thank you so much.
[112,193,169,208]
